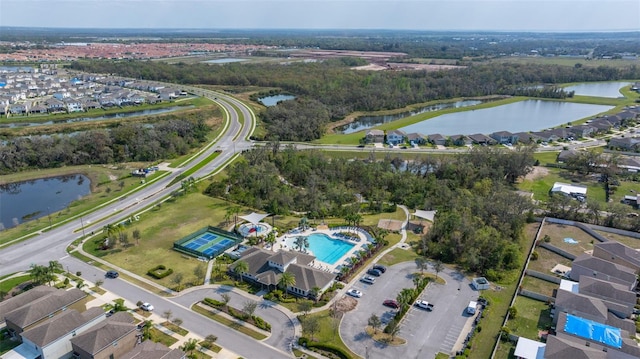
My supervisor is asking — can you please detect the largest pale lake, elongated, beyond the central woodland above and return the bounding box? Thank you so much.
[400,100,613,136]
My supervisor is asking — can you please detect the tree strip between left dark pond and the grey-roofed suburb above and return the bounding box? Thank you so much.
[0,119,210,173]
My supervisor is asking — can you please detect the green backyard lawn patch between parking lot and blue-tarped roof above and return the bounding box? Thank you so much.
[507,296,551,340]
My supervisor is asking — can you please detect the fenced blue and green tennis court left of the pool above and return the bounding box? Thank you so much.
[173,227,240,259]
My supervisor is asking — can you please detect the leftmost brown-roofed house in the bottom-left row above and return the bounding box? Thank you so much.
[4,288,87,336]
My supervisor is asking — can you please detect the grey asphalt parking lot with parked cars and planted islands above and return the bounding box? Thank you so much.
[340,262,479,359]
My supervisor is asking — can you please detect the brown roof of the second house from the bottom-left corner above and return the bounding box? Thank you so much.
[21,307,105,347]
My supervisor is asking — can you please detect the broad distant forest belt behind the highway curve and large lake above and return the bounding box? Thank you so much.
[70,59,640,140]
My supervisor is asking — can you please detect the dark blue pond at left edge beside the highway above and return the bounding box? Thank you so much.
[0,174,91,229]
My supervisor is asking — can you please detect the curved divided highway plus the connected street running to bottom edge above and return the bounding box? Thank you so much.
[0,88,291,359]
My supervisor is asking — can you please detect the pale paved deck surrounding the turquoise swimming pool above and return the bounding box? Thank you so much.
[273,228,370,273]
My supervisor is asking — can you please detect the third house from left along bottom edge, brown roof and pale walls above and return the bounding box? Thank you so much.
[71,312,140,359]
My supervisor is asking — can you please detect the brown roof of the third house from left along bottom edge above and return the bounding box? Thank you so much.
[71,312,136,354]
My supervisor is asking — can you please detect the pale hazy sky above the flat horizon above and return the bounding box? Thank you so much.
[0,0,640,32]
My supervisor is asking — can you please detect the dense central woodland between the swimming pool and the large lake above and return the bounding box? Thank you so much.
[204,143,534,278]
